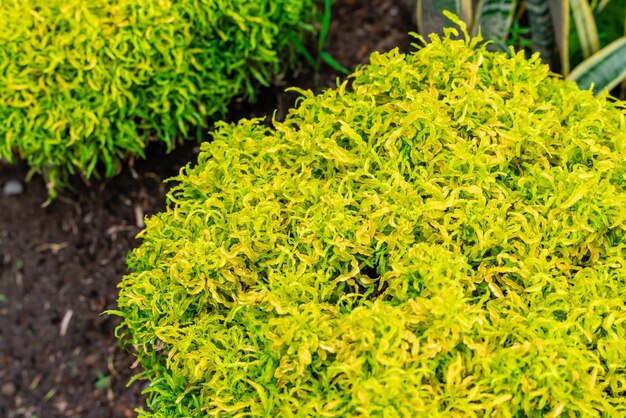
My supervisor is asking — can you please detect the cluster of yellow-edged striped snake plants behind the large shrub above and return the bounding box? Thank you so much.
[406,0,626,98]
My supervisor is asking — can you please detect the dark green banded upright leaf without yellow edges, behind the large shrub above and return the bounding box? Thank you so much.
[526,0,555,68]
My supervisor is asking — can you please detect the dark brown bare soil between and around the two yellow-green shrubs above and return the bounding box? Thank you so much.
[0,0,413,418]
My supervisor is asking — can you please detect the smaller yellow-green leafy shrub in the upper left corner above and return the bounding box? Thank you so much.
[0,0,317,195]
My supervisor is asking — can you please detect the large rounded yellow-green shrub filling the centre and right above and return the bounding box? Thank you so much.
[115,18,626,417]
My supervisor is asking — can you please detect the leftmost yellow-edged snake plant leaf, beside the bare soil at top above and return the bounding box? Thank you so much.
[416,0,472,37]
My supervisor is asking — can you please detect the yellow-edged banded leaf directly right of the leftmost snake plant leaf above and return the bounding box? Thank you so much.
[472,0,517,42]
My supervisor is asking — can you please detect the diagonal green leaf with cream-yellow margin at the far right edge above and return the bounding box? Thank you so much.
[567,36,626,94]
